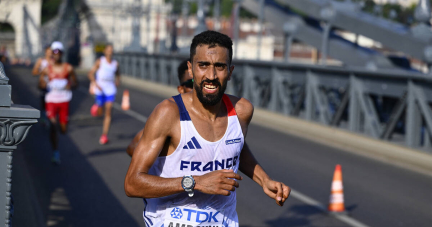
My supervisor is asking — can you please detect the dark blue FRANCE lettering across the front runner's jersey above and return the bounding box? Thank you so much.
[180,156,238,172]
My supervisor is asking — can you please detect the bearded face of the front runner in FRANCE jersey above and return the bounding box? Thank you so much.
[188,45,234,106]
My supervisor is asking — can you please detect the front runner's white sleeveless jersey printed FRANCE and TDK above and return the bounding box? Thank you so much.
[143,94,244,227]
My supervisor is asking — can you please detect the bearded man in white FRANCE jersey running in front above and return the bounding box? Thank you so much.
[125,31,290,227]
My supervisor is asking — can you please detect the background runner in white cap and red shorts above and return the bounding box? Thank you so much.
[39,41,78,164]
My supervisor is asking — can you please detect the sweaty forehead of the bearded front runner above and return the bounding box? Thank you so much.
[193,45,229,63]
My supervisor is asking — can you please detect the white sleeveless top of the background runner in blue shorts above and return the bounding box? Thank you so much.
[95,57,118,96]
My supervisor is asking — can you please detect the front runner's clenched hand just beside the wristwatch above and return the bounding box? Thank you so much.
[194,169,242,196]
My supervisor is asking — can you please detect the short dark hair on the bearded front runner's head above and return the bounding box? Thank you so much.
[190,30,232,64]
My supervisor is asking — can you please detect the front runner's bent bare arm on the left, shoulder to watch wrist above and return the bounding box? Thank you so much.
[125,100,184,198]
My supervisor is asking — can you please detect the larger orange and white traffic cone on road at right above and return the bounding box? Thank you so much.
[328,164,345,213]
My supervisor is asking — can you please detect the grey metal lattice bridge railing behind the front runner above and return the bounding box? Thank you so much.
[115,53,432,153]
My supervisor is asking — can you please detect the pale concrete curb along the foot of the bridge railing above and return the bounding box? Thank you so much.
[122,76,432,176]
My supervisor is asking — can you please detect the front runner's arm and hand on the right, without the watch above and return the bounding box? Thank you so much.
[236,98,291,206]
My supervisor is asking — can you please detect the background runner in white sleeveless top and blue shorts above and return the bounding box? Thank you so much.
[88,44,120,144]
